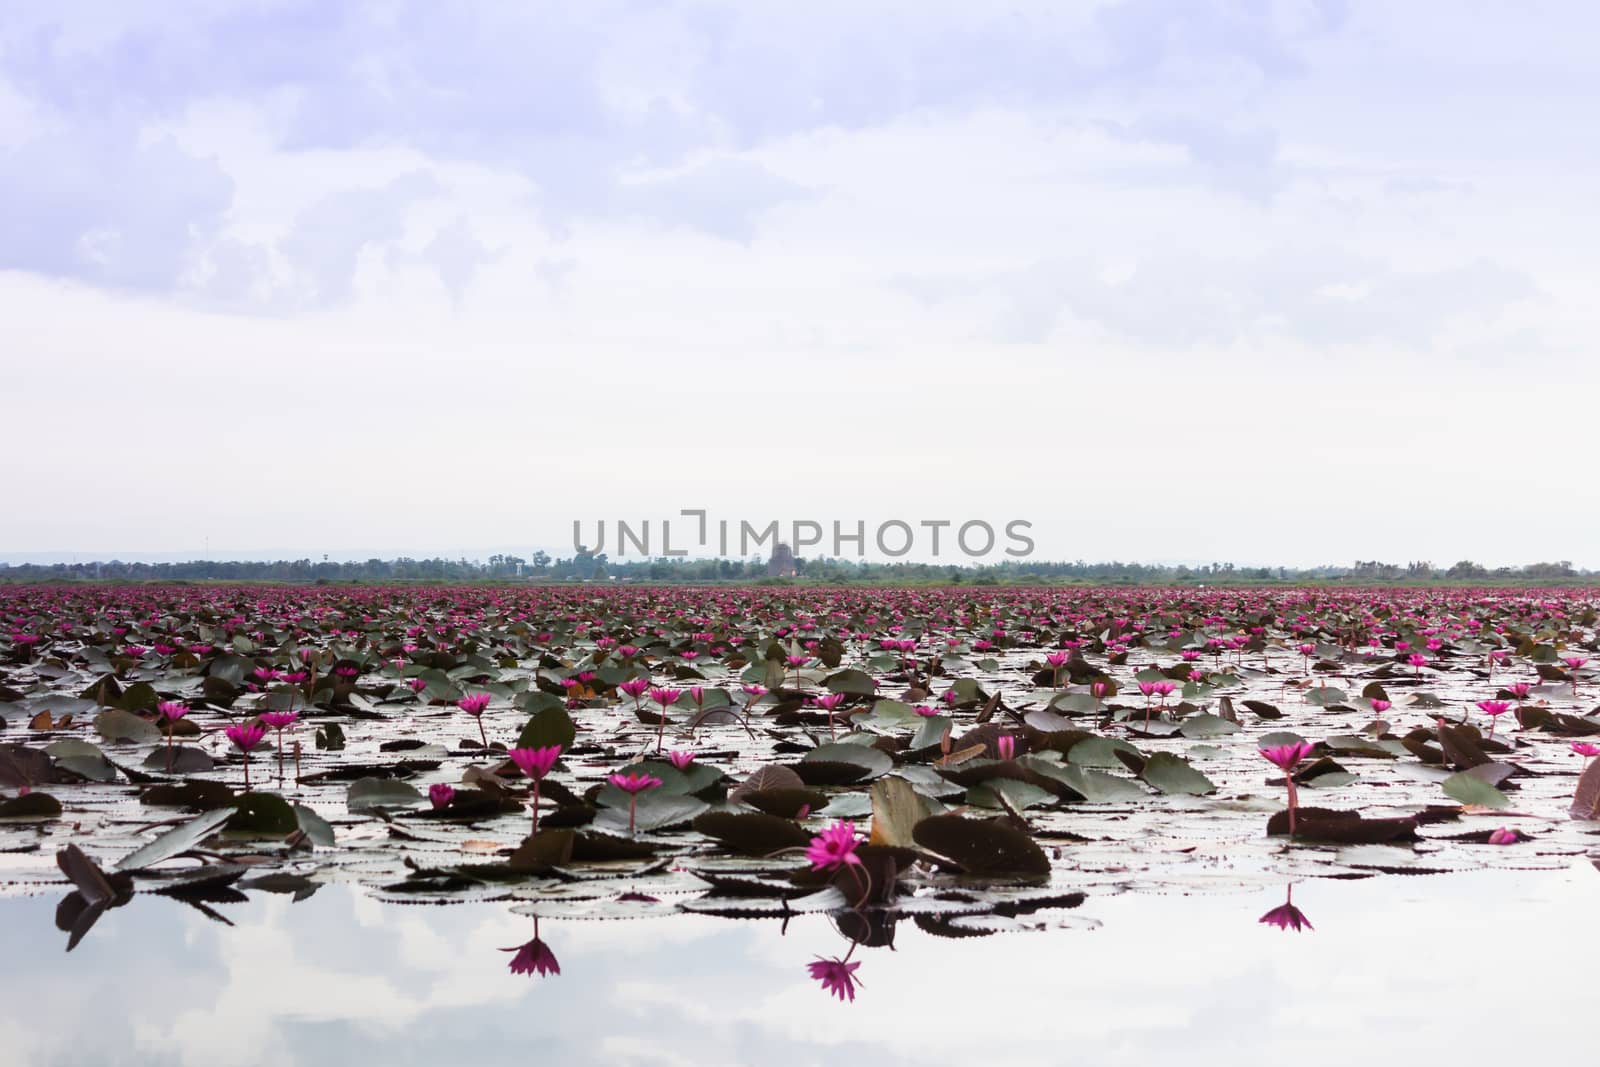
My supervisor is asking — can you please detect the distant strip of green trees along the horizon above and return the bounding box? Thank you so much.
[0,552,1600,585]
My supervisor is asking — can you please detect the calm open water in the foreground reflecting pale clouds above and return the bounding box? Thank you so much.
[0,864,1600,1067]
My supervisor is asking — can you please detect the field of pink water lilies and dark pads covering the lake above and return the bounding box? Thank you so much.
[0,585,1600,972]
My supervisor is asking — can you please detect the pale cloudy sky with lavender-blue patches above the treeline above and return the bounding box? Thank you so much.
[0,0,1600,566]
